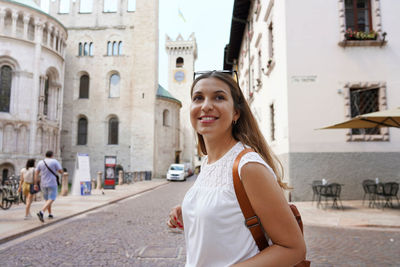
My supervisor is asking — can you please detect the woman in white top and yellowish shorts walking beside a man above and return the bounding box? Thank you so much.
[18,159,35,220]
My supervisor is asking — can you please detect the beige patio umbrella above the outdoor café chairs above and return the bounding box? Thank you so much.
[321,107,400,129]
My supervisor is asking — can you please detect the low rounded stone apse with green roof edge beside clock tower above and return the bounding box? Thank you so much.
[154,85,182,177]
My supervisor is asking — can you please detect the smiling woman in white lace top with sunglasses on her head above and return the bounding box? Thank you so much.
[167,71,306,267]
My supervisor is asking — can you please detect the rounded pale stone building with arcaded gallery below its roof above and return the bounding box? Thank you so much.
[0,0,68,182]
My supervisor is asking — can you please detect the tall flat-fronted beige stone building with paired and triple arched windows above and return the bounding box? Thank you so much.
[49,0,159,180]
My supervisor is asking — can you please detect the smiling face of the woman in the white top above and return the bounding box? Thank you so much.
[190,77,239,142]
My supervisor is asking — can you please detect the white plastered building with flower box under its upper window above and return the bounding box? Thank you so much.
[224,0,400,200]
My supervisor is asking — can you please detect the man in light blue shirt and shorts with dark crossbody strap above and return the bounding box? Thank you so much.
[34,151,64,222]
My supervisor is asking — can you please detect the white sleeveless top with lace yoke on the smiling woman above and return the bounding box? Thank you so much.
[182,142,273,267]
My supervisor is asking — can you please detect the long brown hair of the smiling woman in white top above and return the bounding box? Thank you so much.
[190,71,289,189]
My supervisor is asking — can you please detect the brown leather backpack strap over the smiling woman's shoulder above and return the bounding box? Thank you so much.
[232,148,268,251]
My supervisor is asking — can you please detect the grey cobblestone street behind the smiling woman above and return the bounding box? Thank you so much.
[0,176,400,267]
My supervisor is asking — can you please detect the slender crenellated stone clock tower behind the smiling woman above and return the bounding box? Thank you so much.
[165,33,197,166]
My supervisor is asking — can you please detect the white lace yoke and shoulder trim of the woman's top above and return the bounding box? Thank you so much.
[193,142,273,189]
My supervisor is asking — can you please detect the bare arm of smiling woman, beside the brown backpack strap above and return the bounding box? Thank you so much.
[234,163,306,267]
